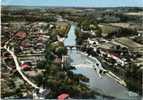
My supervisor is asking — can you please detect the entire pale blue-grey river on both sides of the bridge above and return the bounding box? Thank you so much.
[64,24,138,100]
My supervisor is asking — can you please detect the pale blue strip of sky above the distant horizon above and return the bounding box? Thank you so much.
[1,0,143,7]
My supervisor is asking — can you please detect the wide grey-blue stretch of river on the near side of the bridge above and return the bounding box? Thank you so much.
[69,50,136,100]
